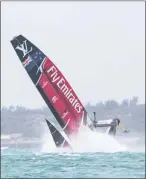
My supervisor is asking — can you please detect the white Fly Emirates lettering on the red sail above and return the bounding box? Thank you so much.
[47,65,82,113]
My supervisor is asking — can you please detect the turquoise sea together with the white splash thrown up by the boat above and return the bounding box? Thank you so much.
[1,129,145,178]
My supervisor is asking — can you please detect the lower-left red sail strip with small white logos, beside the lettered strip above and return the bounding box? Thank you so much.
[39,73,78,134]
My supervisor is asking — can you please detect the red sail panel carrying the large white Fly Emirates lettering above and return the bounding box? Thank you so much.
[43,58,84,127]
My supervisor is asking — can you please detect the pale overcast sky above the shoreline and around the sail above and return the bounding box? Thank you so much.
[1,1,145,108]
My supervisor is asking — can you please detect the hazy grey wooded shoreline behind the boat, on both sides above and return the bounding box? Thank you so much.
[1,96,145,137]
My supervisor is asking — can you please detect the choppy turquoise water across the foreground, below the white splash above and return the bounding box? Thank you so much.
[1,149,145,178]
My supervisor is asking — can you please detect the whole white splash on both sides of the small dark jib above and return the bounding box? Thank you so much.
[41,127,127,153]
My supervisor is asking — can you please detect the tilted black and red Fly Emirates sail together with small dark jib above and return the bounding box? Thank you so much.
[11,35,128,148]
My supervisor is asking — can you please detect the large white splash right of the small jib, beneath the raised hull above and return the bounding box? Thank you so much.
[73,128,126,152]
